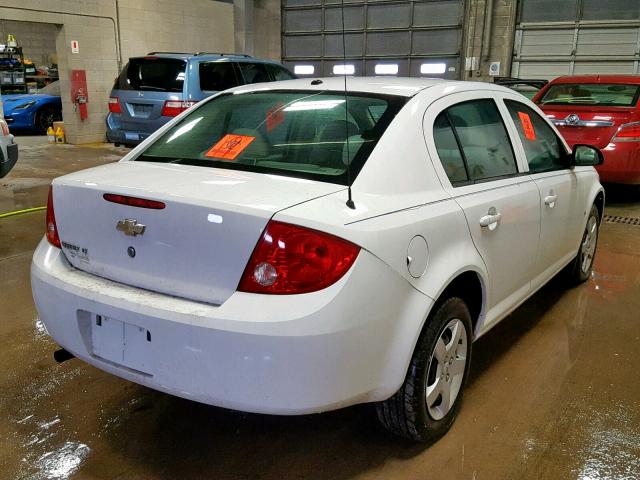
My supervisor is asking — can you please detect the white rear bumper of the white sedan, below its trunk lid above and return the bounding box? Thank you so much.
[31,240,432,414]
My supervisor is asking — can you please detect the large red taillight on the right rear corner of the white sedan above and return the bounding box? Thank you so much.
[238,221,360,294]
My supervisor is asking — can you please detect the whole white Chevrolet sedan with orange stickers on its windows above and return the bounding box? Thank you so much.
[32,78,604,441]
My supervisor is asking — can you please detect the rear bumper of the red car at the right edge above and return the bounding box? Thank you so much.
[596,142,640,185]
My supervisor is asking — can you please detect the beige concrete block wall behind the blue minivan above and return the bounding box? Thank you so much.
[0,0,234,143]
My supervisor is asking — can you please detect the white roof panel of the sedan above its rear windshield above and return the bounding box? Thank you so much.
[231,76,513,97]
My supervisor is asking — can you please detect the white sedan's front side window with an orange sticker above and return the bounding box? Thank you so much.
[504,100,568,173]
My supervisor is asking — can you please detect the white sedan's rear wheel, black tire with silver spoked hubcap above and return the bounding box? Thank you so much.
[376,297,472,442]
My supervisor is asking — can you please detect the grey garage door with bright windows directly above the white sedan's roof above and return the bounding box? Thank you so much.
[282,0,464,79]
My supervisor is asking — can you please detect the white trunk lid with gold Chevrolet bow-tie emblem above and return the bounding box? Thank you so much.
[53,162,344,304]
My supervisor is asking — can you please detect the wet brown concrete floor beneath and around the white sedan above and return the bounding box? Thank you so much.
[0,139,640,480]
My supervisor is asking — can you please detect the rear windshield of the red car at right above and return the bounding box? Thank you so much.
[540,83,638,107]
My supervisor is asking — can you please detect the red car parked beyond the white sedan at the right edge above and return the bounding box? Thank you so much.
[533,75,640,184]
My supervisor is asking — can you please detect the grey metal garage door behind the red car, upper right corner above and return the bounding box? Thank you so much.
[511,0,640,79]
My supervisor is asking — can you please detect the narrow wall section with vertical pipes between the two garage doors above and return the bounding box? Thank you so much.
[464,0,518,81]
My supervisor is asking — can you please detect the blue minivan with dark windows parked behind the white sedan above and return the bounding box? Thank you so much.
[107,52,296,146]
